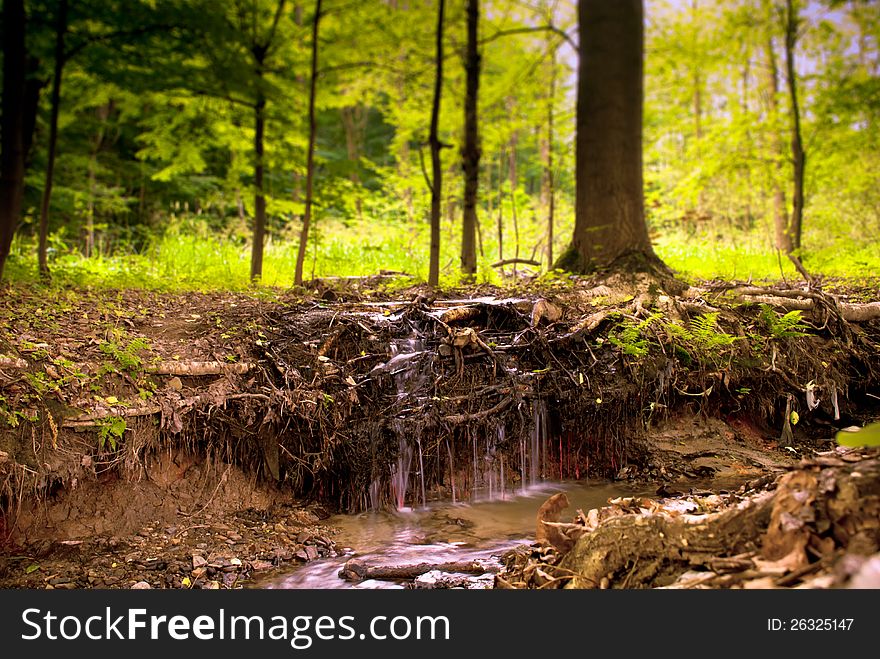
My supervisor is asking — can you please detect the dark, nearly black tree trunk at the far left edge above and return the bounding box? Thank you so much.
[0,0,26,277]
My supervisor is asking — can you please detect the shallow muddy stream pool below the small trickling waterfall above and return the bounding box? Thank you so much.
[254,482,652,588]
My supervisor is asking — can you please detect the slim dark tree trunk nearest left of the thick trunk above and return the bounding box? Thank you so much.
[461,0,480,278]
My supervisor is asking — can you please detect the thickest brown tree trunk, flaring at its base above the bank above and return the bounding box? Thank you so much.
[557,0,656,272]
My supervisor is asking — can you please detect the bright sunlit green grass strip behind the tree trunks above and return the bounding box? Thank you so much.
[7,221,880,291]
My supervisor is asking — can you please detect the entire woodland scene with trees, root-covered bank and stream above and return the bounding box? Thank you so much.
[0,0,880,589]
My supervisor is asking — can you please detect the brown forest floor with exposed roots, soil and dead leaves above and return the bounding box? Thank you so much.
[0,270,880,588]
